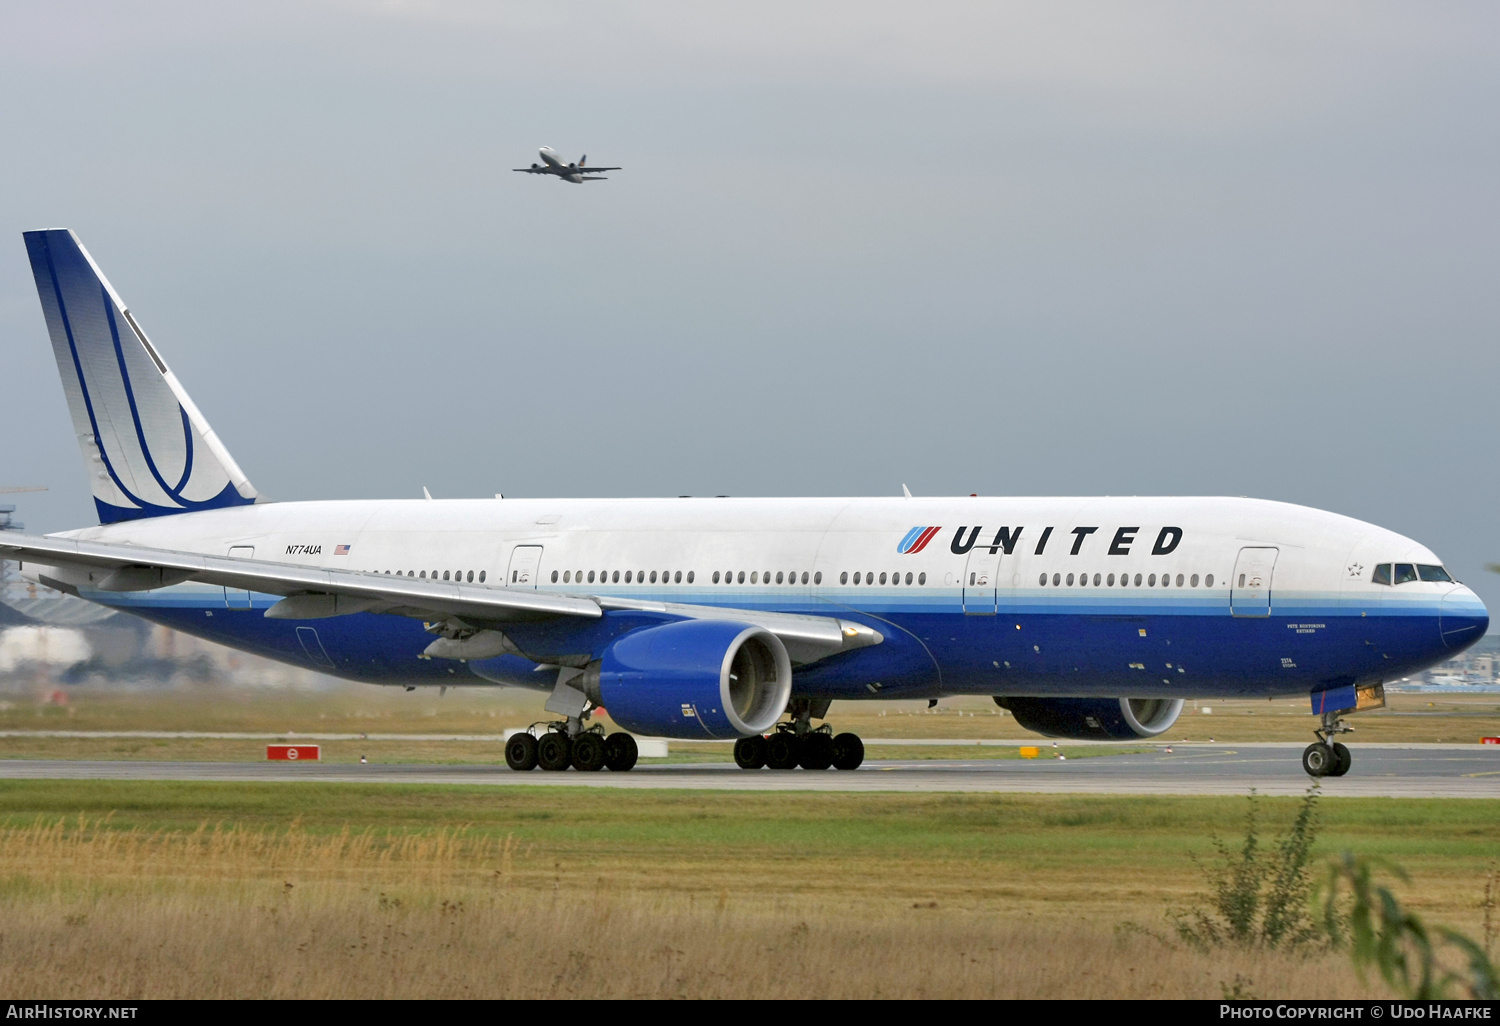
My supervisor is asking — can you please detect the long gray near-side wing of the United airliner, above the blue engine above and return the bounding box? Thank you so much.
[0,531,884,663]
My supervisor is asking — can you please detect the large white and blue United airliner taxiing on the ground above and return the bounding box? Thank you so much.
[0,230,1490,776]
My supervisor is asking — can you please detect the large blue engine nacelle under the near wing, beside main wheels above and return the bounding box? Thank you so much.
[599,620,792,740]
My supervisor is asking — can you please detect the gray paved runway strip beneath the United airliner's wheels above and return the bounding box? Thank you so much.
[0,743,1500,798]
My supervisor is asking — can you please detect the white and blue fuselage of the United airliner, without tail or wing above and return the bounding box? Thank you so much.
[46,498,1488,699]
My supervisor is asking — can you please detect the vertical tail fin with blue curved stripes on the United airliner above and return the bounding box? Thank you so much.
[24,228,260,524]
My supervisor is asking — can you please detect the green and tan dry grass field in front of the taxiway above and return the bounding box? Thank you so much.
[0,782,1500,998]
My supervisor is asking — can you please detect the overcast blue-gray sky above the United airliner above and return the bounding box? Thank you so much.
[0,0,1500,606]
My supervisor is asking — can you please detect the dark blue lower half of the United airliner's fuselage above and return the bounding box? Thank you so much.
[90,593,1488,699]
